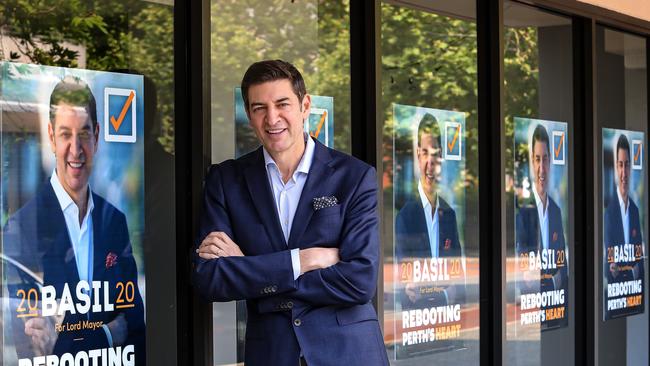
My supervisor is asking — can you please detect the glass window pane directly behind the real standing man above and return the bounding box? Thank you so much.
[210,0,350,365]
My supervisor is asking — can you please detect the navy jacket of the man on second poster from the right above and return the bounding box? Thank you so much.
[515,196,569,329]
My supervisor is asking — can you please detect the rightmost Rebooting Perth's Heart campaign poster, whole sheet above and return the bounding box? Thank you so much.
[602,128,647,320]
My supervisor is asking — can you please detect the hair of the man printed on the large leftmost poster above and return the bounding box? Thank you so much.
[50,76,97,129]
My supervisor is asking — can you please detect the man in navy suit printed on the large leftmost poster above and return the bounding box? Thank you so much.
[3,77,145,365]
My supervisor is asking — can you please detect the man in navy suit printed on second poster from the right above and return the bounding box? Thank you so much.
[515,125,569,329]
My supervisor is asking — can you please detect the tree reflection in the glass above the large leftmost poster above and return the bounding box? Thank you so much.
[0,0,174,152]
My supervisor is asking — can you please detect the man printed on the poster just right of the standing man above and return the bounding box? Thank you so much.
[395,113,464,308]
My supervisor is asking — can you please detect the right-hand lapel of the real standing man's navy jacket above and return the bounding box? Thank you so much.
[289,140,332,249]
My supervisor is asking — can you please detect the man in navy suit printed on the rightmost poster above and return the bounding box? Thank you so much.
[604,135,644,283]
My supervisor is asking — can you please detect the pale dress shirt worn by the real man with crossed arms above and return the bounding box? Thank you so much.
[262,134,316,280]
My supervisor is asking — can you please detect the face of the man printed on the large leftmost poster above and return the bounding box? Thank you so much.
[47,104,99,200]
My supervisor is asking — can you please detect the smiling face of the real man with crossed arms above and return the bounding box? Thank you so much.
[247,79,311,157]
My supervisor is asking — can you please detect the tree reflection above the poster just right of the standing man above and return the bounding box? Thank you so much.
[382,4,478,199]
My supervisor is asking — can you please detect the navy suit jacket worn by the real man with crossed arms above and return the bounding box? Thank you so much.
[193,141,388,366]
